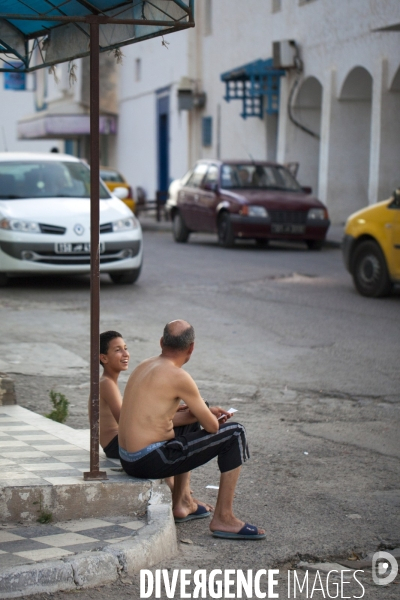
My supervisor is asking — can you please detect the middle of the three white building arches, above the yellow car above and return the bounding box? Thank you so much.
[331,67,372,221]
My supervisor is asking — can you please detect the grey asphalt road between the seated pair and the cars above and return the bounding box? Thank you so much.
[0,231,400,600]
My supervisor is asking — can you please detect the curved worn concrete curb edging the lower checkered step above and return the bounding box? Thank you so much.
[0,481,178,599]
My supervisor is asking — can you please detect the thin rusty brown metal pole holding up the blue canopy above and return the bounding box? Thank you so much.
[83,17,107,481]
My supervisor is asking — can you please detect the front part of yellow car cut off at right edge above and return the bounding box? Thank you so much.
[342,188,400,298]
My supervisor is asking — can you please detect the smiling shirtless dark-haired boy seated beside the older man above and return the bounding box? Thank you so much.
[95,331,129,458]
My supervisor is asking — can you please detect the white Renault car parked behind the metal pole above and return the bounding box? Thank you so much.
[0,152,143,285]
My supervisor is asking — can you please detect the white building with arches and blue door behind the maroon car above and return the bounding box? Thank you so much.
[116,0,400,223]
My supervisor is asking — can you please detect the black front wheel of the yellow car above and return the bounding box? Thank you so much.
[352,241,391,298]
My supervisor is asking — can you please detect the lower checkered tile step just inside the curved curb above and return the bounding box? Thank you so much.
[0,516,145,571]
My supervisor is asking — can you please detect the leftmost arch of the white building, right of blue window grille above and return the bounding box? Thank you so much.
[290,77,322,194]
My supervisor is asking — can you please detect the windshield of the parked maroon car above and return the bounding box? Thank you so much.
[221,164,301,192]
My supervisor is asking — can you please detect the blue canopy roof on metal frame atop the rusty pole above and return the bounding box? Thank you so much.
[0,0,194,72]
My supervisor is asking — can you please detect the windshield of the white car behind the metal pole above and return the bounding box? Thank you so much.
[0,160,110,200]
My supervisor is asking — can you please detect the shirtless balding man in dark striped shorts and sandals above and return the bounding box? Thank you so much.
[119,320,265,540]
